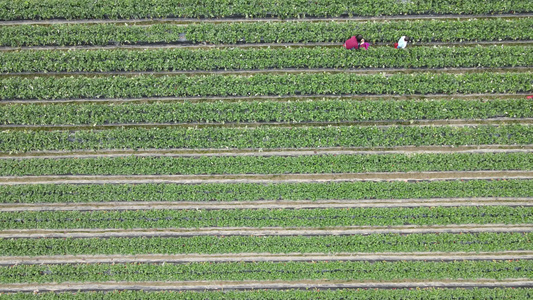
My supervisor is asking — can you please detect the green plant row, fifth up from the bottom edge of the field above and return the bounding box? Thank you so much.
[0,179,533,203]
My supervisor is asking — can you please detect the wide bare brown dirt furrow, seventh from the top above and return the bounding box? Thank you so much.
[0,171,533,185]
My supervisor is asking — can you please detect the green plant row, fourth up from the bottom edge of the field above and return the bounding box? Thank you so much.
[0,206,533,229]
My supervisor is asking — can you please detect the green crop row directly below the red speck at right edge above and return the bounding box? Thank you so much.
[0,98,533,125]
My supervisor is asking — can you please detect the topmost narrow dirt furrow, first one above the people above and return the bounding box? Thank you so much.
[0,13,533,26]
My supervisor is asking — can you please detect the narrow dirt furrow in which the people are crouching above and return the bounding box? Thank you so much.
[0,40,533,52]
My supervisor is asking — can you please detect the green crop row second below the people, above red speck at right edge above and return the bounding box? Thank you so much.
[0,72,533,100]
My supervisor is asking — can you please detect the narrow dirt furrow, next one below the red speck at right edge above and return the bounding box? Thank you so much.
[0,118,533,130]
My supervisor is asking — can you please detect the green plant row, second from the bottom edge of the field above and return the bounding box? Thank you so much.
[0,260,533,283]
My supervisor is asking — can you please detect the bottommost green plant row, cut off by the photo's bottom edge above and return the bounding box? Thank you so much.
[0,288,533,300]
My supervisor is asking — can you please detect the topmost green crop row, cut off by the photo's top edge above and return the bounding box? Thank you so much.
[0,0,533,20]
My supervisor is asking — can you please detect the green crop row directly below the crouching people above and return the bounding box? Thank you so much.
[4,46,533,73]
